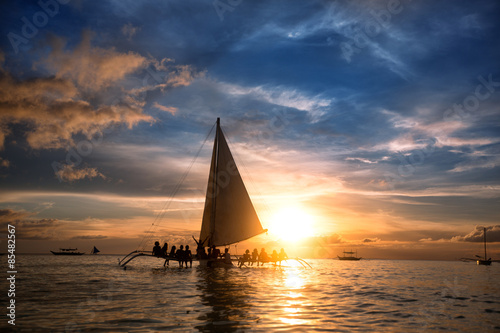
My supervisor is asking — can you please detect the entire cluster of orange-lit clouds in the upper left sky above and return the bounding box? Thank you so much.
[0,31,203,153]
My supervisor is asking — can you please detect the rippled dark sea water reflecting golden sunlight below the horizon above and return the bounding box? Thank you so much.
[0,255,500,332]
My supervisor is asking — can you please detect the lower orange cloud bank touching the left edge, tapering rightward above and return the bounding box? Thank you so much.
[0,73,152,149]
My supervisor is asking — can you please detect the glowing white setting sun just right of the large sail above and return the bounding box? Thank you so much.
[268,207,314,241]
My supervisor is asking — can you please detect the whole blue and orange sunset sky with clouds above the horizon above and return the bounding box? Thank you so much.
[0,0,500,259]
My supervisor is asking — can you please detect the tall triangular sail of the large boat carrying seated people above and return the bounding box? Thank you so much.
[200,119,265,246]
